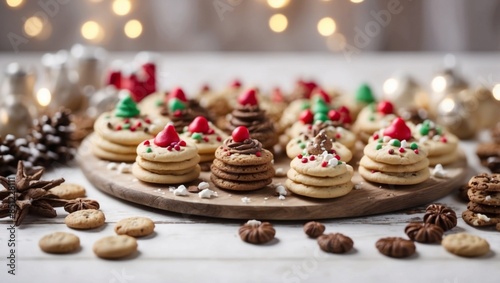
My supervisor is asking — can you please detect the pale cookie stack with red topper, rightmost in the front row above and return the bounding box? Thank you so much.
[358,118,430,185]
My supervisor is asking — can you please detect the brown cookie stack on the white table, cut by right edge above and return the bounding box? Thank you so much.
[462,173,500,230]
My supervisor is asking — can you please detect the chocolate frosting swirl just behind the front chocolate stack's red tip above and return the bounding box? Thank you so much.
[227,105,274,134]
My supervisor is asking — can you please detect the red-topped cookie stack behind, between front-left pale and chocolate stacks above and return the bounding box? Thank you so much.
[181,116,227,170]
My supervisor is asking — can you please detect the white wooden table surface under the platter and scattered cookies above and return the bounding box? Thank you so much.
[0,53,500,283]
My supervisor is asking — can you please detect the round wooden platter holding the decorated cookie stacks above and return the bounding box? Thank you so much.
[78,138,467,220]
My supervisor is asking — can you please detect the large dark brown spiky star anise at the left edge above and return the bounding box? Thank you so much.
[0,161,67,226]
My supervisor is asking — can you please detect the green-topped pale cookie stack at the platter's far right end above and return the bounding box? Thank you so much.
[414,120,458,166]
